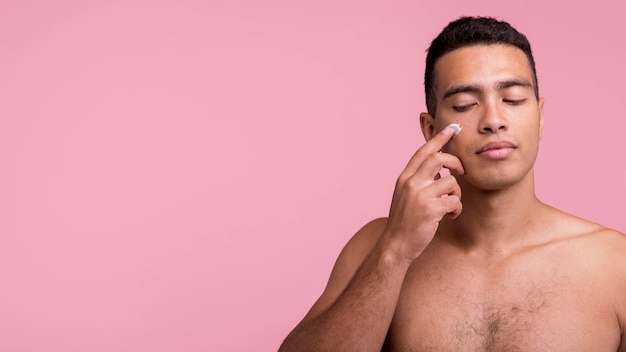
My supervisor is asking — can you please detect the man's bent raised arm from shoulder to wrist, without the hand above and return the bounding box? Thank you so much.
[280,219,409,352]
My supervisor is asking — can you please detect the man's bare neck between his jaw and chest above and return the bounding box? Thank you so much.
[440,173,545,255]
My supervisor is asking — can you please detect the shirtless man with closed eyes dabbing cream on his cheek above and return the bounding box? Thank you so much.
[281,17,626,352]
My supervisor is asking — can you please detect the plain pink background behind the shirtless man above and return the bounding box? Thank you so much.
[0,0,626,352]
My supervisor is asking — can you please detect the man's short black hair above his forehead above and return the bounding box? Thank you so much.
[424,17,539,117]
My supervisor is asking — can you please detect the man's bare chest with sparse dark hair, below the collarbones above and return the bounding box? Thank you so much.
[387,250,620,351]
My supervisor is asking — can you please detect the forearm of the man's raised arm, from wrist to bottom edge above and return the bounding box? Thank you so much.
[280,243,409,352]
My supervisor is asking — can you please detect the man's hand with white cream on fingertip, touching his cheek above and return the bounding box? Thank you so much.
[384,127,465,263]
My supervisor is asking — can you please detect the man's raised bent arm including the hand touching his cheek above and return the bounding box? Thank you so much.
[280,128,464,352]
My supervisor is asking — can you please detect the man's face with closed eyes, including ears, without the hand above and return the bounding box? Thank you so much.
[422,44,543,190]
